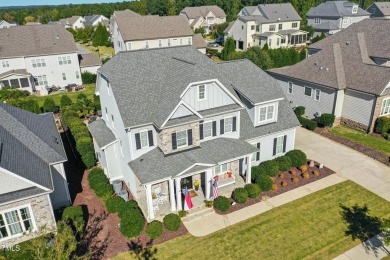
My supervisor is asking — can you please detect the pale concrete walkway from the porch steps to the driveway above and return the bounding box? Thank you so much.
[184,174,345,237]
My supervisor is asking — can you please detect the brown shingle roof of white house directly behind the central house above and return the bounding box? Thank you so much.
[116,15,194,41]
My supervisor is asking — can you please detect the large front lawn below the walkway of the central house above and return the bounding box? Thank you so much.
[115,181,390,260]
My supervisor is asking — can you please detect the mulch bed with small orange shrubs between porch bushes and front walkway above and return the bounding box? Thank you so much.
[214,160,335,215]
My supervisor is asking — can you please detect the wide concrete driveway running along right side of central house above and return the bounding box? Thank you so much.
[295,127,390,201]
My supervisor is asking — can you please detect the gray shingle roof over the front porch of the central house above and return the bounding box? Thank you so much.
[129,138,257,184]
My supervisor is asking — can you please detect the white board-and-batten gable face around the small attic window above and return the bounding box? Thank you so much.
[182,82,236,111]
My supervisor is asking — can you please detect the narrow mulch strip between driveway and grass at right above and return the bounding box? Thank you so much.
[314,127,390,166]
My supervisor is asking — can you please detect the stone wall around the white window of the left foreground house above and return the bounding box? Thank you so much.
[0,194,55,246]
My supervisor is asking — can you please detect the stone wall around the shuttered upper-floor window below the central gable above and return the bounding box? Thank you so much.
[158,122,200,154]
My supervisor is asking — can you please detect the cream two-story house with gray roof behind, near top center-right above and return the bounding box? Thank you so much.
[224,3,308,50]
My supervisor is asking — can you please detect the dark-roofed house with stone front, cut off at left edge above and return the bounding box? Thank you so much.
[0,103,70,247]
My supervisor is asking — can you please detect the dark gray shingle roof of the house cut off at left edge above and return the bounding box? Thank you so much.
[0,103,67,189]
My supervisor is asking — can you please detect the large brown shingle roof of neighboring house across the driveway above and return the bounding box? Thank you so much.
[269,19,390,95]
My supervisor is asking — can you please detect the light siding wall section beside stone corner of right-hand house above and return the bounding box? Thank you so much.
[341,89,375,126]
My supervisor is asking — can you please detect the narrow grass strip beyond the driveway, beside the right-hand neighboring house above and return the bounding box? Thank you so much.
[330,125,390,154]
